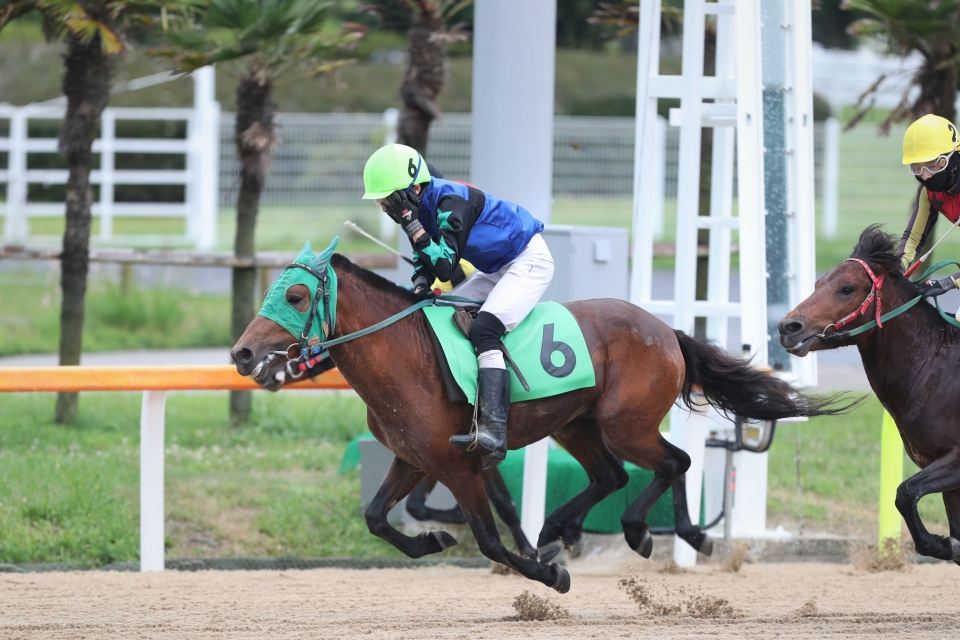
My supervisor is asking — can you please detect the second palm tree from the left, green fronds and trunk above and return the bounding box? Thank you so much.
[159,0,363,424]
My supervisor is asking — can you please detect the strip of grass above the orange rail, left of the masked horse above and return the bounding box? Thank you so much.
[0,271,231,355]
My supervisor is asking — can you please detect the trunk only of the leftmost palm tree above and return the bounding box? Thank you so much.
[55,36,114,424]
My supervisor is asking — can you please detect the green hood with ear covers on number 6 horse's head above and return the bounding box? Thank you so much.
[258,237,340,339]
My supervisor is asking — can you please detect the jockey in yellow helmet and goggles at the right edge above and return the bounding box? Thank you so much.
[897,114,960,297]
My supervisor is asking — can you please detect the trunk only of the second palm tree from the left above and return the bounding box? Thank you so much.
[230,74,276,426]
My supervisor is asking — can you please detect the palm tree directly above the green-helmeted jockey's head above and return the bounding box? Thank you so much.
[363,0,473,155]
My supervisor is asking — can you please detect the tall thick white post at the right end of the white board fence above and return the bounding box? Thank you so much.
[187,66,220,250]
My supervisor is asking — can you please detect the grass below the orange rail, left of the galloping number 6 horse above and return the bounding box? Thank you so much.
[0,393,412,566]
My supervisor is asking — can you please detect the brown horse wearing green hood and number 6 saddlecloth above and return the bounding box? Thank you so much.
[231,254,840,593]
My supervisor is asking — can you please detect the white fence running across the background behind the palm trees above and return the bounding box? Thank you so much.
[0,105,860,249]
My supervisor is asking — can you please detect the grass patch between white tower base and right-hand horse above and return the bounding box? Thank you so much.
[767,395,949,542]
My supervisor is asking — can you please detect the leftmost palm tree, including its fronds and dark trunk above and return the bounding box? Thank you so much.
[0,0,195,424]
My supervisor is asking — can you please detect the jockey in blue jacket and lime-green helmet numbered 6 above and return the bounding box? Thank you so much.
[363,144,553,460]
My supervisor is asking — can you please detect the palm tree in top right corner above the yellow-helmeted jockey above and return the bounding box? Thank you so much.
[841,0,960,127]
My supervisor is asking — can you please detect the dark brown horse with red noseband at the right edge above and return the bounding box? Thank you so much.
[779,225,960,564]
